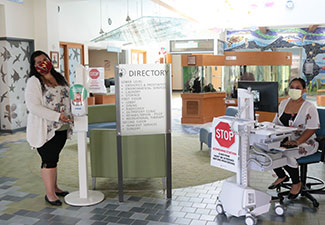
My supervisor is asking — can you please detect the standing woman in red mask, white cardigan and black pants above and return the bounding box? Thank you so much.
[25,51,72,206]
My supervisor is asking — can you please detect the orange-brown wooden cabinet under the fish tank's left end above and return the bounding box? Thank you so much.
[181,92,226,124]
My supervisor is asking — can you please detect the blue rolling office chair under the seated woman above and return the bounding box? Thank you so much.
[278,109,325,207]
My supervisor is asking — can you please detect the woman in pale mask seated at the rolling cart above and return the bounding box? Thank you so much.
[269,78,319,199]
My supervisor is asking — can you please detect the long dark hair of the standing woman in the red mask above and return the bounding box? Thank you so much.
[29,50,69,91]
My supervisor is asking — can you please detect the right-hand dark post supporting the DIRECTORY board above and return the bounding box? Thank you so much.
[166,64,172,198]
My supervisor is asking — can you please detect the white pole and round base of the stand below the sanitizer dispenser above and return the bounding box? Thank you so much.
[64,116,104,206]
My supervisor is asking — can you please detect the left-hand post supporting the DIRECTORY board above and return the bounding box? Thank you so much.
[115,66,124,202]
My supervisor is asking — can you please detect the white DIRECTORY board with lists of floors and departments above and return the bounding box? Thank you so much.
[115,64,170,135]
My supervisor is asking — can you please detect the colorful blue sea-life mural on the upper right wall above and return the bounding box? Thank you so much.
[225,27,325,89]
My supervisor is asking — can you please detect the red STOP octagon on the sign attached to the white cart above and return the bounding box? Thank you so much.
[215,122,235,148]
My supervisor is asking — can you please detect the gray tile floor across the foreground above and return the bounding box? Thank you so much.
[0,168,325,225]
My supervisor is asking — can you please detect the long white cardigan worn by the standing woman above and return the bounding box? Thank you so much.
[25,76,60,148]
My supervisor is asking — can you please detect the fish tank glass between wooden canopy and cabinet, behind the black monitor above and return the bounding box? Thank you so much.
[183,66,291,98]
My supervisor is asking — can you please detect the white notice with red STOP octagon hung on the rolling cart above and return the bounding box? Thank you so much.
[211,117,239,172]
